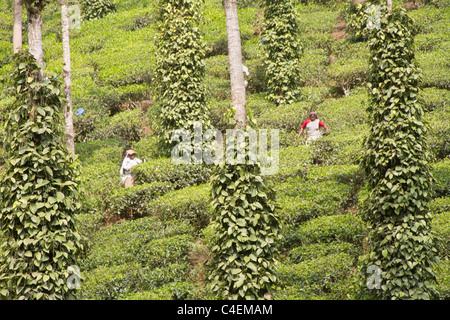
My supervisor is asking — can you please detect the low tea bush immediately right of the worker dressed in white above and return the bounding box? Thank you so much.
[132,158,210,189]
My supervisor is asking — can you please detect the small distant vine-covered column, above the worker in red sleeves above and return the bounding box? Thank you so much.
[263,0,301,105]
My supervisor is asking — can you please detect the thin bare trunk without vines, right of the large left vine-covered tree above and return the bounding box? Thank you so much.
[61,1,75,153]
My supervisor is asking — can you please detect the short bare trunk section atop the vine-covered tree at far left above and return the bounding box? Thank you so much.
[25,0,45,69]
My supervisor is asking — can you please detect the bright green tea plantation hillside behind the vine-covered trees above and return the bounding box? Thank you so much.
[0,0,450,300]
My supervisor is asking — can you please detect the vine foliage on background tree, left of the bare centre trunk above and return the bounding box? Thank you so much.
[156,0,209,145]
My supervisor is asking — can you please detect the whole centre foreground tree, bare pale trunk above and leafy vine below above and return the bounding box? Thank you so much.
[208,0,280,299]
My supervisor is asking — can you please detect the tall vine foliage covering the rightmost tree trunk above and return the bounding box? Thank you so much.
[362,7,437,299]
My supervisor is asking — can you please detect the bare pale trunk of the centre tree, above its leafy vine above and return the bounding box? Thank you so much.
[222,0,247,129]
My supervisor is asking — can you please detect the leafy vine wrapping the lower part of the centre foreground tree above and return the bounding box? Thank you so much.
[208,137,281,299]
